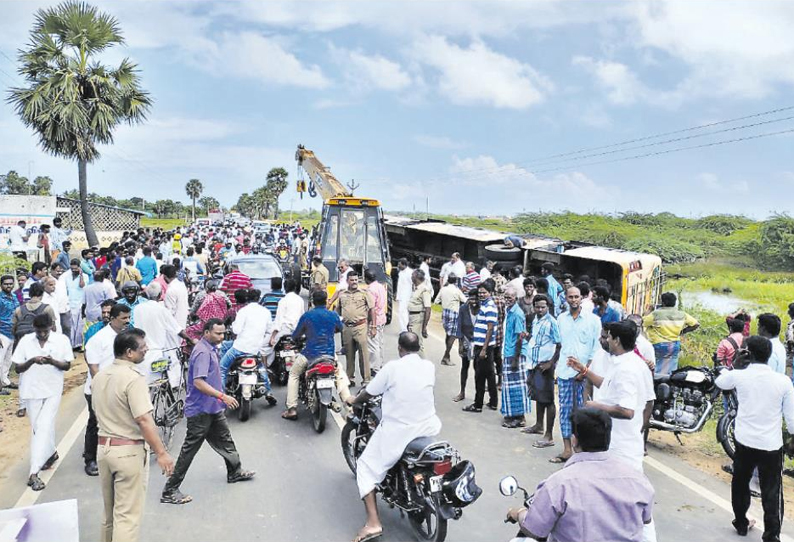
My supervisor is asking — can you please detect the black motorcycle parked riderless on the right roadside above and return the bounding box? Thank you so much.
[650,366,736,457]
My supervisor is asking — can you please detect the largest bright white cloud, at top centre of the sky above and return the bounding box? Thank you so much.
[412,36,553,109]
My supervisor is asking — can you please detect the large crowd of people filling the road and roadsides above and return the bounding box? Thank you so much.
[0,220,794,540]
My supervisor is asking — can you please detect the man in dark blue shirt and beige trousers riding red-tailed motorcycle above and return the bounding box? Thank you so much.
[281,291,350,420]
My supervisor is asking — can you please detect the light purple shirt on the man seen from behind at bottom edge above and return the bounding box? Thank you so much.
[522,452,654,542]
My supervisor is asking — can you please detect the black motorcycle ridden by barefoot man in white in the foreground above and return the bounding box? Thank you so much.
[342,397,482,542]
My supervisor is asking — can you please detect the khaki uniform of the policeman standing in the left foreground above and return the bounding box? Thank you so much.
[91,359,153,542]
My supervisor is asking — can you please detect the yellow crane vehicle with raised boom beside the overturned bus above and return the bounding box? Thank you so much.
[295,145,393,320]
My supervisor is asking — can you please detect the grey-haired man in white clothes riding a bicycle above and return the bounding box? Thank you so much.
[132,282,195,388]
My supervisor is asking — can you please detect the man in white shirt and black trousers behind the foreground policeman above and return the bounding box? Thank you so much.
[83,302,131,476]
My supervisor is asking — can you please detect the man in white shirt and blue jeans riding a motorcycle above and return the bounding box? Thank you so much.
[221,298,276,405]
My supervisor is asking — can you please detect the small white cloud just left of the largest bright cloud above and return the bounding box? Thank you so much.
[331,45,411,92]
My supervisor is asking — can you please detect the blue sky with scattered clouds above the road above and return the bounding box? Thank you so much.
[0,0,794,218]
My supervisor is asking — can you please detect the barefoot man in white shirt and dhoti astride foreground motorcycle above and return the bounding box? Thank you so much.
[348,332,441,542]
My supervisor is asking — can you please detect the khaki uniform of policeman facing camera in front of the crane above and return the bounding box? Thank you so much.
[339,289,374,383]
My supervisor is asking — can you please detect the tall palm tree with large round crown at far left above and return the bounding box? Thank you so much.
[8,0,152,245]
